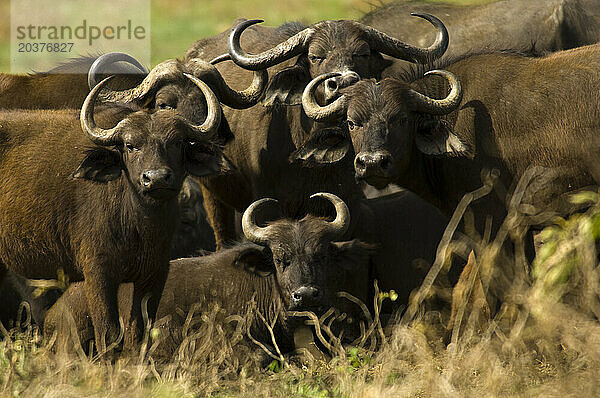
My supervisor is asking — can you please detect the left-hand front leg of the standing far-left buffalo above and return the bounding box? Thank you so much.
[83,272,121,353]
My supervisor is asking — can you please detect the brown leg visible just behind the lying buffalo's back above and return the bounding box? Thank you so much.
[202,184,237,251]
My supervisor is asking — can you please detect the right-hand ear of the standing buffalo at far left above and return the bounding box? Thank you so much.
[185,143,235,177]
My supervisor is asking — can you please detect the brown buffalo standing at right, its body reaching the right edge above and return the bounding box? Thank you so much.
[305,45,600,236]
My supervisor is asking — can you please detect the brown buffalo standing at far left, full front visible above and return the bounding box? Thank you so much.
[0,61,264,348]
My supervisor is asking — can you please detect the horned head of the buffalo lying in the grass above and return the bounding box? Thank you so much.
[242,193,372,312]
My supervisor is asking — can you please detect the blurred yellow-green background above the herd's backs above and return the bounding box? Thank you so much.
[0,0,488,72]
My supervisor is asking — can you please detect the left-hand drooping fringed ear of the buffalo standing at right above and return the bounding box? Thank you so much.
[288,129,351,167]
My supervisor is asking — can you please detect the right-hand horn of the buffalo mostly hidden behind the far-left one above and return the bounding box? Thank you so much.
[186,54,269,109]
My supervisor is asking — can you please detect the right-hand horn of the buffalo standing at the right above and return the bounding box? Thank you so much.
[409,69,462,115]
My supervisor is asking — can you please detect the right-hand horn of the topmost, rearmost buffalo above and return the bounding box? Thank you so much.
[356,13,448,64]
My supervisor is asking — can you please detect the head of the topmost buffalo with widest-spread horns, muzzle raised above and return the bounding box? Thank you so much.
[229,14,448,105]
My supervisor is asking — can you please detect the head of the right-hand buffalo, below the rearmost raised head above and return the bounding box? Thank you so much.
[303,70,470,189]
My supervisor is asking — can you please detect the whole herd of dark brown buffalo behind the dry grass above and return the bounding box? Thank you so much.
[0,0,600,360]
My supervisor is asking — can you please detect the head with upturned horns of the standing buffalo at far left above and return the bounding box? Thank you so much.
[73,64,234,203]
